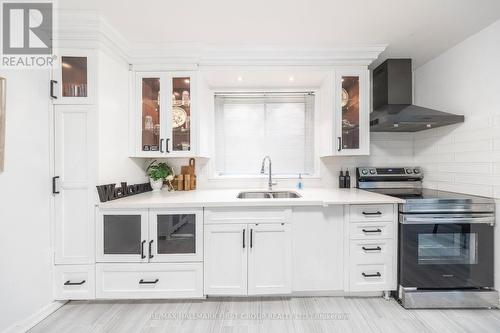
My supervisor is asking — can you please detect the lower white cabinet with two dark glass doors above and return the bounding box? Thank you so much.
[96,208,203,263]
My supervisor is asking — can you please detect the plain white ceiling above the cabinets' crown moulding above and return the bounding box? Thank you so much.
[58,0,500,67]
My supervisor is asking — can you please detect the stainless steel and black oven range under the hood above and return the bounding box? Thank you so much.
[356,167,499,308]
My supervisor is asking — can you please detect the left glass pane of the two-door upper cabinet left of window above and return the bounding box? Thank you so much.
[140,77,163,153]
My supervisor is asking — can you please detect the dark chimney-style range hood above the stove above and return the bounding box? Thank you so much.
[370,59,464,132]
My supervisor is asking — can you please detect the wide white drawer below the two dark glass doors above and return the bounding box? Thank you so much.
[96,262,203,299]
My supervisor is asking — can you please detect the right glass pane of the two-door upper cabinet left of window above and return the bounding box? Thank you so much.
[171,76,192,152]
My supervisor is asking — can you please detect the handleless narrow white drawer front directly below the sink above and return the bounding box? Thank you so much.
[204,207,291,224]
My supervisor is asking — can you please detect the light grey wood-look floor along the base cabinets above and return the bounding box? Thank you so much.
[30,297,500,333]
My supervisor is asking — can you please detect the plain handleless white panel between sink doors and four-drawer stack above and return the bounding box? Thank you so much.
[292,205,344,294]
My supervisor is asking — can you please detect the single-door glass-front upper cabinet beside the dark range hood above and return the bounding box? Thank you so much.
[334,70,370,155]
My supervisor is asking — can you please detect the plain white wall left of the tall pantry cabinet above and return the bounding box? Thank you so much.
[0,69,52,331]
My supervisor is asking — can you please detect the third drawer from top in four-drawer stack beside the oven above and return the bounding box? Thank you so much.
[350,239,394,264]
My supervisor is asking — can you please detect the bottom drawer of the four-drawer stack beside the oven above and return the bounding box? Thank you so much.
[349,262,395,291]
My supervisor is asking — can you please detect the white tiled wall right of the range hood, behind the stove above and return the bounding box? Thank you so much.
[414,21,500,289]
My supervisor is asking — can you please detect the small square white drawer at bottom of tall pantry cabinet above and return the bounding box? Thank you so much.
[53,265,95,300]
